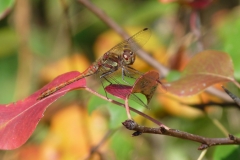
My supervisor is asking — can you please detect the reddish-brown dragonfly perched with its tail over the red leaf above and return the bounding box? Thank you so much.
[38,28,154,103]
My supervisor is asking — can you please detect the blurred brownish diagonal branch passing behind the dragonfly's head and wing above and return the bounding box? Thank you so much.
[78,0,169,77]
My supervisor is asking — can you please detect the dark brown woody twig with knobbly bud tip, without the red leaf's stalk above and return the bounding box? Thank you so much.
[123,120,240,150]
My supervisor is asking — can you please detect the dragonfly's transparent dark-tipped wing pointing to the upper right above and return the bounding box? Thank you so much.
[108,28,151,54]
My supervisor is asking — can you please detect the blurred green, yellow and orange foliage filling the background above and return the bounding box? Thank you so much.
[0,0,240,160]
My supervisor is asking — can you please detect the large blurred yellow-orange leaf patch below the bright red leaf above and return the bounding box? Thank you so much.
[41,104,107,160]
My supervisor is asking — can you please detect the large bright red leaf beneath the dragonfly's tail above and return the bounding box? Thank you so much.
[0,71,86,150]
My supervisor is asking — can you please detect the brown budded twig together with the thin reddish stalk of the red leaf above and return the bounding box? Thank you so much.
[85,88,240,150]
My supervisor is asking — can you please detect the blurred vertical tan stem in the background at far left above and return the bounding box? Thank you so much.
[14,1,34,99]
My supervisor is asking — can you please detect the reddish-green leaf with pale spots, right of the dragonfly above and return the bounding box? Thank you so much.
[164,50,235,96]
